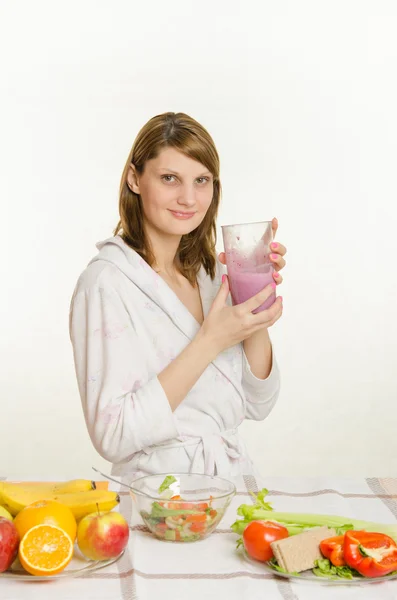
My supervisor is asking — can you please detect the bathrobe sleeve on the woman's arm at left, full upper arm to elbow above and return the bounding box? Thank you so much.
[70,284,178,463]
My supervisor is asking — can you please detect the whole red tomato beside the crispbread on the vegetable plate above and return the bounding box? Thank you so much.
[243,521,288,562]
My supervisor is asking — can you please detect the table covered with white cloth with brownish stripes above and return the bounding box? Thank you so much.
[0,476,397,600]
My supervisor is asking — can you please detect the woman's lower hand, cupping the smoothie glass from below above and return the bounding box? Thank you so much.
[200,275,283,357]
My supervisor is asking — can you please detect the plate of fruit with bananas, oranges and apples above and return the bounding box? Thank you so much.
[0,479,129,581]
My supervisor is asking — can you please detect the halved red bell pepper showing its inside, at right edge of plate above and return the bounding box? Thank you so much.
[343,531,397,577]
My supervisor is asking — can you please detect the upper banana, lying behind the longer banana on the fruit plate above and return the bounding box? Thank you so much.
[0,480,100,516]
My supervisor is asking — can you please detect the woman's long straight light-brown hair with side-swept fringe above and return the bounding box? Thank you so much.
[114,112,221,284]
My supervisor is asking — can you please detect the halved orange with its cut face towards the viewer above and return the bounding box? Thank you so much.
[18,525,73,576]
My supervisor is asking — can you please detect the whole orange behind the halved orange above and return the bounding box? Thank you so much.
[14,500,77,542]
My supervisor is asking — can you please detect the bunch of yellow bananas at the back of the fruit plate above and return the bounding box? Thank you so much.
[0,479,120,521]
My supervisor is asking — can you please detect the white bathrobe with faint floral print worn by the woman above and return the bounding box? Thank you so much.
[70,236,280,478]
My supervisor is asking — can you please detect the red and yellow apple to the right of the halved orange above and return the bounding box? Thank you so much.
[77,511,130,560]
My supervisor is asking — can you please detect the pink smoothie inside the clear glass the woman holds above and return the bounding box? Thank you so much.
[228,265,276,313]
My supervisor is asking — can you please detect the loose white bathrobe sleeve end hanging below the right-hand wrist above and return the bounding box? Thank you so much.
[242,349,280,421]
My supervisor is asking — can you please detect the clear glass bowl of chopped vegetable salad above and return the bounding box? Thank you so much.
[130,473,236,542]
